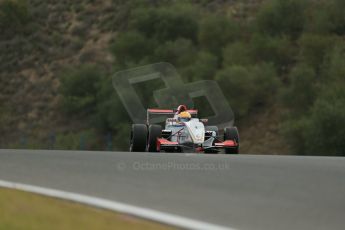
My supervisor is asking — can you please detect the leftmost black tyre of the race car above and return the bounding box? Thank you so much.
[129,124,147,152]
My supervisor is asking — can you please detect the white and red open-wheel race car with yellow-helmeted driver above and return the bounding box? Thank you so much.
[129,105,240,154]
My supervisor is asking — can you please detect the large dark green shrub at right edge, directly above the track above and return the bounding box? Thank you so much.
[282,43,345,155]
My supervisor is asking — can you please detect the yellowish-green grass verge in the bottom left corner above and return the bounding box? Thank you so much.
[0,188,172,230]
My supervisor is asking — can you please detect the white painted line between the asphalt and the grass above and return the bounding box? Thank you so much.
[0,180,235,230]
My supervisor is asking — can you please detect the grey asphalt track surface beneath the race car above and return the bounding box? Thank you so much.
[0,150,345,230]
